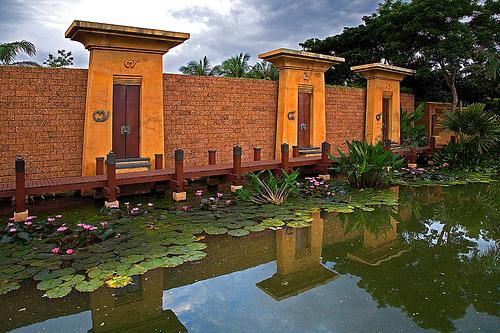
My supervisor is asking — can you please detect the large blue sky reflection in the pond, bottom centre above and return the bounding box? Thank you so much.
[163,262,442,333]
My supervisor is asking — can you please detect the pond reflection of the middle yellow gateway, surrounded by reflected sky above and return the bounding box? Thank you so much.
[257,213,337,301]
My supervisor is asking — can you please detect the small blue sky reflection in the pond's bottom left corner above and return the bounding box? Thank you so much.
[10,311,92,333]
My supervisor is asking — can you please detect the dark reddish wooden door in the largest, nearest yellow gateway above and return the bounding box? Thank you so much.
[113,84,141,158]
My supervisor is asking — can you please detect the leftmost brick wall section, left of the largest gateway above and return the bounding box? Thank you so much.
[0,66,87,182]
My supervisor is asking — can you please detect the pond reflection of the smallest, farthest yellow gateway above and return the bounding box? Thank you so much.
[347,188,411,266]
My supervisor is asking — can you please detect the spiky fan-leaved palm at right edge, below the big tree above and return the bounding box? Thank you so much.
[441,103,500,154]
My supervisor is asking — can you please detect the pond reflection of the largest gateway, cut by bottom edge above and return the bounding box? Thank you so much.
[89,269,187,333]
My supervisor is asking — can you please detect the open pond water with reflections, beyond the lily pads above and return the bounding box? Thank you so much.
[0,183,500,332]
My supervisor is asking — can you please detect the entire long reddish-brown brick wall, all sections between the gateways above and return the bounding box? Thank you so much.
[0,66,414,182]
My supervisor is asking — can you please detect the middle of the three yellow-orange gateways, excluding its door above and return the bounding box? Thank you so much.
[259,49,344,157]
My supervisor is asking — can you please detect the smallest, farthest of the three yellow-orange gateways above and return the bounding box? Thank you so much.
[351,64,415,144]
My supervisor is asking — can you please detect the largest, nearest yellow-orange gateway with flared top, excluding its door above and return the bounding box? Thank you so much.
[66,21,189,176]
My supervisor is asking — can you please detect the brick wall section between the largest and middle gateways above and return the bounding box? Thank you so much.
[163,74,278,165]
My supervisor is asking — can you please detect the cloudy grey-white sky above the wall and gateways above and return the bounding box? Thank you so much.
[0,0,381,72]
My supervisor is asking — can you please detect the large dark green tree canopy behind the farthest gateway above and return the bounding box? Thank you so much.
[300,0,500,105]
